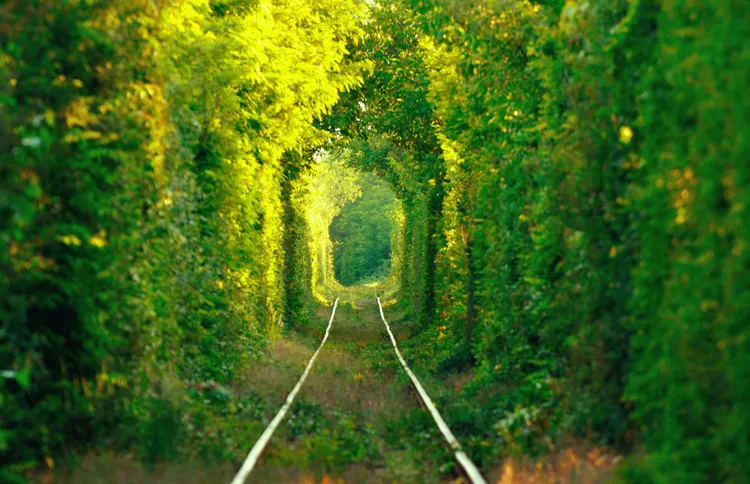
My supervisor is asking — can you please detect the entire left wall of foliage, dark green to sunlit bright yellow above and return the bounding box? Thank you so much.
[0,0,364,470]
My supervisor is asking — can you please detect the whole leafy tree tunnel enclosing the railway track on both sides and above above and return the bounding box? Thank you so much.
[0,0,750,482]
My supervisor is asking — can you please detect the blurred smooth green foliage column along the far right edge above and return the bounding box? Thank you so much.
[626,2,750,482]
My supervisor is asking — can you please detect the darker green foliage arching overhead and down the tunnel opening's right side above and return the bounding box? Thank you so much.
[323,2,444,324]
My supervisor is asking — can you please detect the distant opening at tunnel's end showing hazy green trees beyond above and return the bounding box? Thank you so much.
[329,173,399,286]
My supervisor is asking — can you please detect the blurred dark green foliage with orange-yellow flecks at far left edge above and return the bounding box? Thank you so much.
[0,2,160,469]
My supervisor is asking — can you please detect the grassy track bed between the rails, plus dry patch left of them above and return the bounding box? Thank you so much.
[247,297,455,483]
